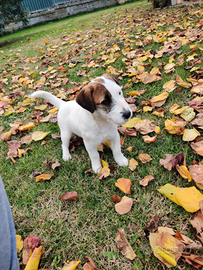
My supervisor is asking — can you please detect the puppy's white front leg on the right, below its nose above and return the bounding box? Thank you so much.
[109,131,128,166]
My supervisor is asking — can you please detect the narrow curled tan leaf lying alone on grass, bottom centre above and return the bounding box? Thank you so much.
[115,228,136,260]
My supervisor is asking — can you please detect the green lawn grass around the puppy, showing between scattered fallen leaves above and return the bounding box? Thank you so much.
[0,1,203,270]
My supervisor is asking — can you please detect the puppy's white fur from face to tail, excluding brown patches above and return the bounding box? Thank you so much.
[31,77,132,173]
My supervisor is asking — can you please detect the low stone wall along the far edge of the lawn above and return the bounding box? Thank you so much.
[5,0,134,31]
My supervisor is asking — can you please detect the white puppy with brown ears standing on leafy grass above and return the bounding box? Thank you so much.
[30,74,132,173]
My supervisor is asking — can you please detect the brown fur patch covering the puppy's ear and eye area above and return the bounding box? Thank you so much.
[76,82,112,113]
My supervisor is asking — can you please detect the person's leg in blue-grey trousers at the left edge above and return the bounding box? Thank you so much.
[0,177,19,270]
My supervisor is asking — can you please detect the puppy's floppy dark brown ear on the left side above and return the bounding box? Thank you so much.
[76,84,96,113]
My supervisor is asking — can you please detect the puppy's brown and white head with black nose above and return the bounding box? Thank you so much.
[76,74,132,125]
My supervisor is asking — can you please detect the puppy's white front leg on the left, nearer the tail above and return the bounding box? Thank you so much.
[84,140,102,173]
